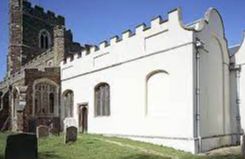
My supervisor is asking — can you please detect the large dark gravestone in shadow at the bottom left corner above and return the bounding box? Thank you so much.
[5,134,38,159]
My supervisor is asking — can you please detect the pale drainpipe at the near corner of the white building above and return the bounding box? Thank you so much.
[195,39,204,153]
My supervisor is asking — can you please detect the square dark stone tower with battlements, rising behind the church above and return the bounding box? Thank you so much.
[8,0,65,74]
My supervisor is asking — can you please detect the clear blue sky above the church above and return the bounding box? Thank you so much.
[0,0,245,80]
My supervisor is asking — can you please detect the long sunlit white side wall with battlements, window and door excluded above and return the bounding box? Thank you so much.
[61,10,195,153]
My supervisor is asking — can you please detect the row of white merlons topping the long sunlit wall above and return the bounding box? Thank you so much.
[62,9,190,65]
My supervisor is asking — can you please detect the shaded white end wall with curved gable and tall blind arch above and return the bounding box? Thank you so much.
[196,9,237,151]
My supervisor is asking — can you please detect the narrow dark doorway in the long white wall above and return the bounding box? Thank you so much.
[79,103,88,133]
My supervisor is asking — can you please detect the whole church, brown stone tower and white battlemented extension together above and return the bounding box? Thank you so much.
[0,0,245,153]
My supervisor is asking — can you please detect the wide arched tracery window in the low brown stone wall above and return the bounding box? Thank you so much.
[33,81,58,116]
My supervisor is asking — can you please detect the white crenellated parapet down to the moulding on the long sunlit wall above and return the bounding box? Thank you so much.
[60,9,202,80]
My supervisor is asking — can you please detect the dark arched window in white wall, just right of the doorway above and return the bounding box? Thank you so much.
[94,83,110,116]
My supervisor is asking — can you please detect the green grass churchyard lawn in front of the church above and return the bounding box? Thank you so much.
[0,133,241,159]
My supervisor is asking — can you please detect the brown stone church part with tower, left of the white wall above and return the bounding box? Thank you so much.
[0,0,90,132]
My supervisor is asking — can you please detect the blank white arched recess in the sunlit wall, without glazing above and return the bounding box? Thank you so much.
[146,70,170,116]
